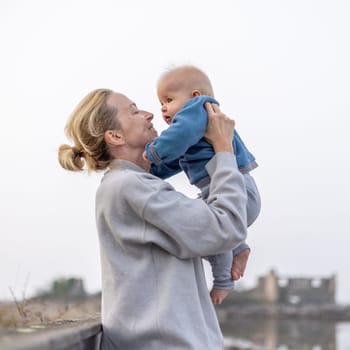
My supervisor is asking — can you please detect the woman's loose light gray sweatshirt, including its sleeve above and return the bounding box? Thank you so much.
[96,152,247,350]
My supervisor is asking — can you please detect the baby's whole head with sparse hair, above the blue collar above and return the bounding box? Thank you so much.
[157,66,214,124]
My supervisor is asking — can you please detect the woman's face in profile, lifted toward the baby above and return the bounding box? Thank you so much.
[107,93,158,149]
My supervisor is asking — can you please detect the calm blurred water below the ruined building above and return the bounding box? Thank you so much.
[221,319,350,350]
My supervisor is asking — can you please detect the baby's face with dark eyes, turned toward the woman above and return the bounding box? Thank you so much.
[157,82,192,124]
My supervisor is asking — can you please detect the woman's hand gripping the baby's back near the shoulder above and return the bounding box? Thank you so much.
[204,102,235,153]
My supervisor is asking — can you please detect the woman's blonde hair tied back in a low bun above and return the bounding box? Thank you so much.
[58,89,120,171]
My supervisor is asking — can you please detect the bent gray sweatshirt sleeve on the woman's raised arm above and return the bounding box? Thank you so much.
[124,152,247,259]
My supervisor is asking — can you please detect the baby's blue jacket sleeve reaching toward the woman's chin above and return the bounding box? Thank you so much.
[146,96,218,165]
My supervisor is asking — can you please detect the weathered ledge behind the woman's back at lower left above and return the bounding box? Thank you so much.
[0,318,102,350]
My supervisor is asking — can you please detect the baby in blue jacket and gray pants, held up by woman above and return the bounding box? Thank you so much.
[144,66,261,304]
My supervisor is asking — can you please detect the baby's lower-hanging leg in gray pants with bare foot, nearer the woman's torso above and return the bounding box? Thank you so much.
[208,251,234,304]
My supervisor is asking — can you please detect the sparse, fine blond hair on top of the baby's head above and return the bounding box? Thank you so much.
[158,65,214,97]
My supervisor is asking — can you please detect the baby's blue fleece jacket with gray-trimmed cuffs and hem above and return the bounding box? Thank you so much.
[146,96,258,185]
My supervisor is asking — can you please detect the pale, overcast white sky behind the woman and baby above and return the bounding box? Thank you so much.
[0,0,350,303]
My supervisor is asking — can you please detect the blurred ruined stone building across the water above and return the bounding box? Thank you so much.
[226,270,336,305]
